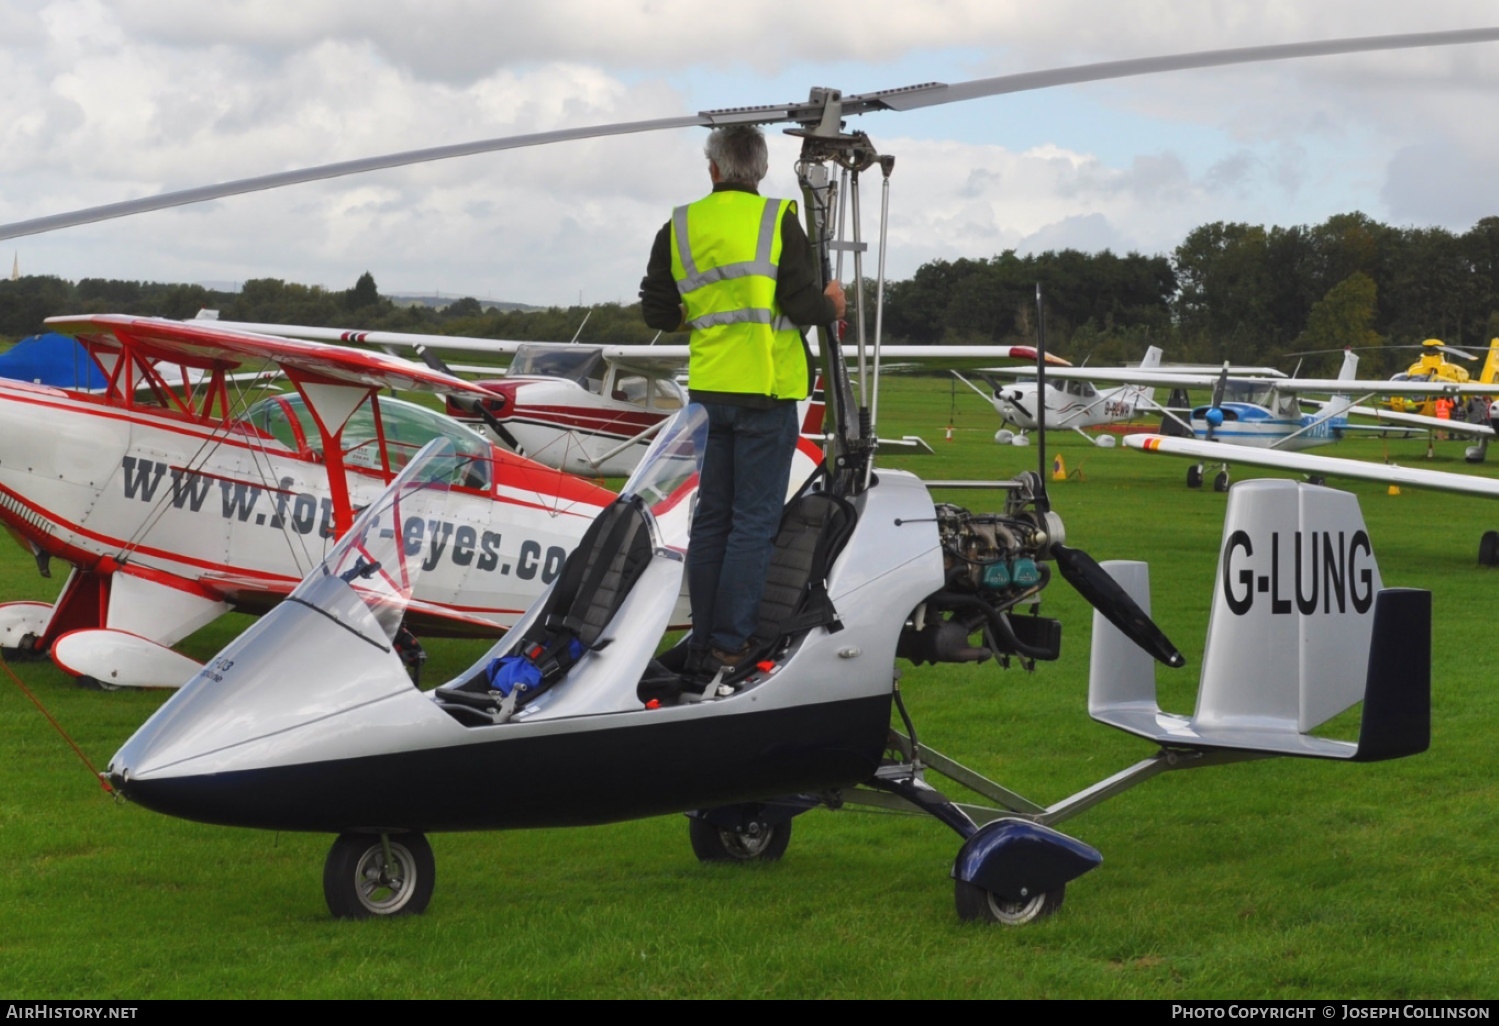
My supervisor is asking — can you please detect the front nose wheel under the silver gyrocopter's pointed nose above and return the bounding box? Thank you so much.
[322,834,438,920]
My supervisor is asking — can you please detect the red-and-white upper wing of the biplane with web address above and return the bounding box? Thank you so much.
[46,314,484,395]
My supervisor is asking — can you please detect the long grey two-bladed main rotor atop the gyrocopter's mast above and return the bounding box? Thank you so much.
[0,29,1499,240]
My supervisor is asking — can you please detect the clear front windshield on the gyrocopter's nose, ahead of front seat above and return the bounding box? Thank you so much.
[289,438,459,648]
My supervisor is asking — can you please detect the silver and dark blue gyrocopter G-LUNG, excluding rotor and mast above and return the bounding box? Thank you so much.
[108,407,1432,924]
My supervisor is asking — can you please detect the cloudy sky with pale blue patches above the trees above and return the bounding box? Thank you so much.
[0,0,1499,309]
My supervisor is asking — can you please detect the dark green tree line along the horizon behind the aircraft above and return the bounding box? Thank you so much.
[0,213,1499,374]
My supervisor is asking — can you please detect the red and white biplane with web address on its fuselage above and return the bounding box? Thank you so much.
[0,315,615,687]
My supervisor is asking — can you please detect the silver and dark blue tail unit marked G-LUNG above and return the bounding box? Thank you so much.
[1088,480,1432,761]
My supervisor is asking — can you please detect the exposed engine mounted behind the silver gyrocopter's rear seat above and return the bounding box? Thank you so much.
[896,474,1064,666]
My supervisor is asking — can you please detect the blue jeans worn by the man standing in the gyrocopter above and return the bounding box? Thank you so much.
[687,402,797,653]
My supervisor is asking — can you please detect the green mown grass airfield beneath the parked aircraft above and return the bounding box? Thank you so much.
[0,378,1499,999]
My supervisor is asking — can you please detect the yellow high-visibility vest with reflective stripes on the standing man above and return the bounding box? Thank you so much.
[672,189,808,399]
